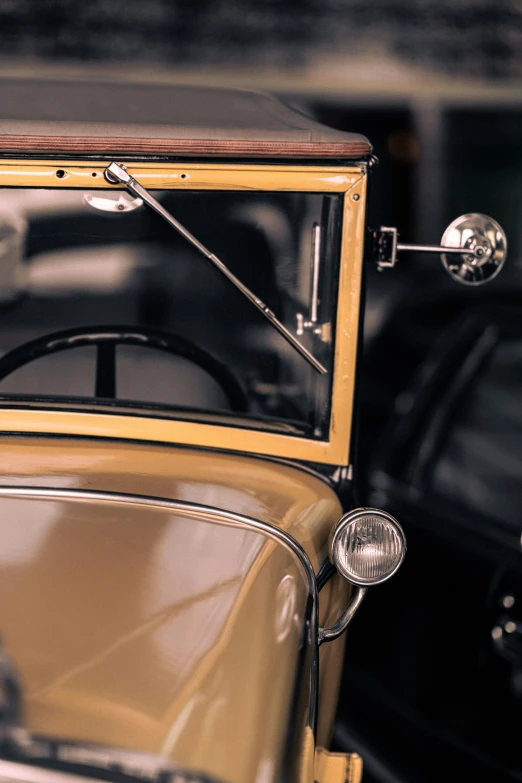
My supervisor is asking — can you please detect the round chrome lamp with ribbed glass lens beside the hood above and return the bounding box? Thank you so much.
[330,508,406,587]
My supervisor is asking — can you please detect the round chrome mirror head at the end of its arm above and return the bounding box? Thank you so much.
[441,212,507,286]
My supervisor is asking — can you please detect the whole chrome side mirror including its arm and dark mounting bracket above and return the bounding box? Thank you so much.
[371,212,507,286]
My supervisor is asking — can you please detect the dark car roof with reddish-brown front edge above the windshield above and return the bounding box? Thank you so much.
[0,78,371,159]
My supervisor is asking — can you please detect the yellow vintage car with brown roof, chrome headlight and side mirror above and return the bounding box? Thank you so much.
[0,79,506,783]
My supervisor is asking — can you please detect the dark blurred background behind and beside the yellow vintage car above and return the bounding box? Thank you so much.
[0,0,522,783]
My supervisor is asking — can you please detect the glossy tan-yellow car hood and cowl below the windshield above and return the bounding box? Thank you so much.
[0,443,337,783]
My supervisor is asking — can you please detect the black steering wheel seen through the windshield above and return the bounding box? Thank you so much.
[0,326,248,413]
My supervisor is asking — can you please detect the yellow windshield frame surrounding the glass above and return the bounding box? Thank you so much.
[0,159,367,465]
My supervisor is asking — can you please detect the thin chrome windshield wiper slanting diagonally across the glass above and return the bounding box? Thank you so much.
[105,162,327,375]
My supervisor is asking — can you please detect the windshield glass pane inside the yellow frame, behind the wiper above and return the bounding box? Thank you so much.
[0,189,342,439]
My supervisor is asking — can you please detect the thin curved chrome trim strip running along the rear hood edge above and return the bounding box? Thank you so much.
[0,485,319,732]
